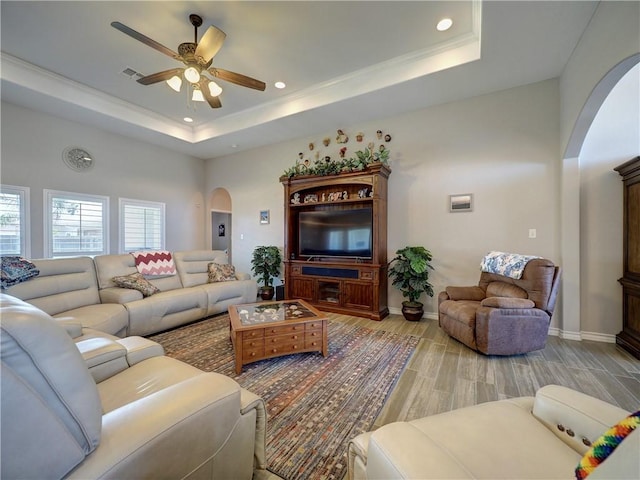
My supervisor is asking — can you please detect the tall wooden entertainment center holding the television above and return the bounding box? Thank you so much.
[280,162,391,320]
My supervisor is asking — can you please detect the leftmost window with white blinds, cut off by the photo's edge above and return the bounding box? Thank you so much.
[0,185,31,258]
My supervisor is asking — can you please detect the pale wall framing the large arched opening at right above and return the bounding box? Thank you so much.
[560,1,640,339]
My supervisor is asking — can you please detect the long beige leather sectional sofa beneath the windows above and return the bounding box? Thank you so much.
[5,250,258,337]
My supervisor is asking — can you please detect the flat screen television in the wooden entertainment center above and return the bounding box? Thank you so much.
[298,207,373,258]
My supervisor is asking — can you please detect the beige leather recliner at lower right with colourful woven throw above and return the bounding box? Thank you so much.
[348,385,640,480]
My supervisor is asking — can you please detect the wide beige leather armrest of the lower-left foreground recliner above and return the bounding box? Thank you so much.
[68,373,254,479]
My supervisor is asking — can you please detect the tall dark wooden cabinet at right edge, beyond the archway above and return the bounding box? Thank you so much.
[615,157,640,358]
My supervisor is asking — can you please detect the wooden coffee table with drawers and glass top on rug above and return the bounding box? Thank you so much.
[229,300,329,374]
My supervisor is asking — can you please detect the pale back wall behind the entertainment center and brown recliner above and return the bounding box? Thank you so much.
[206,80,560,321]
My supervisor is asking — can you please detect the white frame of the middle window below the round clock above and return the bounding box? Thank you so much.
[43,189,109,258]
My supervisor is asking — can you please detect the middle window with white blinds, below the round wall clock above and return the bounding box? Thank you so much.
[44,190,109,257]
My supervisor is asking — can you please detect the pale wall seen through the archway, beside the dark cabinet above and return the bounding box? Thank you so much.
[580,66,640,338]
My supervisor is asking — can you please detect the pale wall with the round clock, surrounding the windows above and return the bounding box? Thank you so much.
[0,103,208,258]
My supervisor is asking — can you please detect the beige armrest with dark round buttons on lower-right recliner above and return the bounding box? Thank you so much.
[533,385,629,455]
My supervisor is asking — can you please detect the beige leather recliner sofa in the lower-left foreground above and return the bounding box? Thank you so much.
[0,294,266,479]
